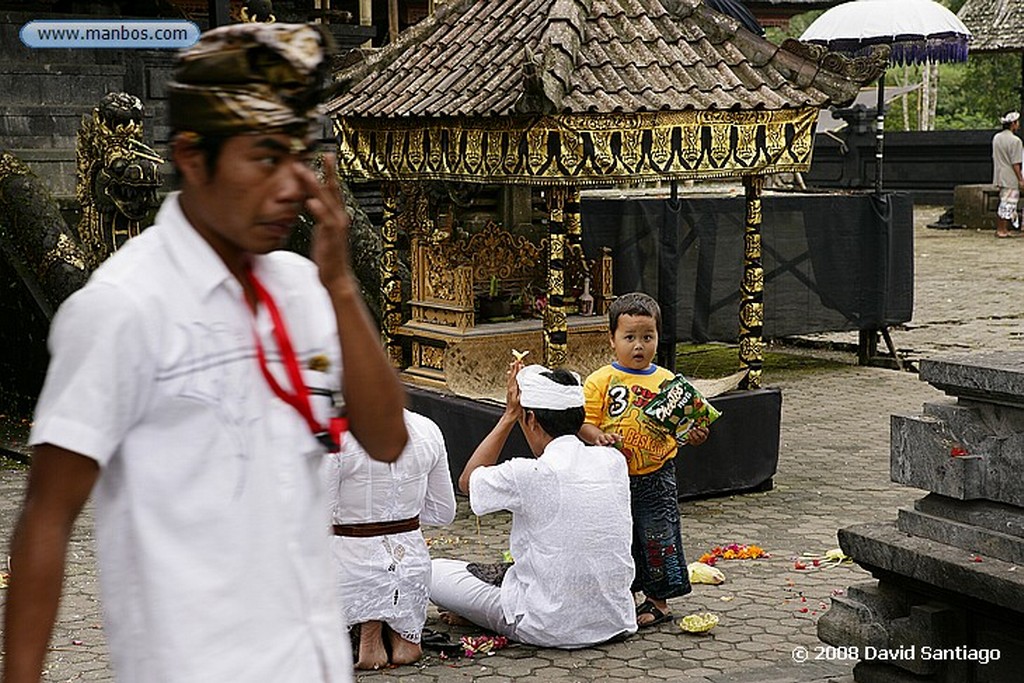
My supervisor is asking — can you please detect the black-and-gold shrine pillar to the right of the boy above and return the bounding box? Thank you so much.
[739,175,765,389]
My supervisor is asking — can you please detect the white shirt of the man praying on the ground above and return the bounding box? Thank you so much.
[469,436,637,647]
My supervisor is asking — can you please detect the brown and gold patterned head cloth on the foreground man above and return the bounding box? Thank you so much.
[168,24,331,136]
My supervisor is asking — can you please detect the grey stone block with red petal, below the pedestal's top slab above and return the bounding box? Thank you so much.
[889,415,986,500]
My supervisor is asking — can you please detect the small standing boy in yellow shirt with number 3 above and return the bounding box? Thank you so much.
[580,292,708,628]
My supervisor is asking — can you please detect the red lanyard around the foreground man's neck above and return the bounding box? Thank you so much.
[248,270,348,453]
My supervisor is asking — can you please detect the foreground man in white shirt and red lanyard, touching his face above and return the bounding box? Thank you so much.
[4,24,407,683]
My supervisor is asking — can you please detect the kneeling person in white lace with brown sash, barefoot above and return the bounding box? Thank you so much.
[326,411,456,669]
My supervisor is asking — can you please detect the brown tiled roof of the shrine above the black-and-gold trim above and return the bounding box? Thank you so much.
[328,0,877,118]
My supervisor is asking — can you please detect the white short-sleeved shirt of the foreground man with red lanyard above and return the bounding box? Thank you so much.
[31,195,352,683]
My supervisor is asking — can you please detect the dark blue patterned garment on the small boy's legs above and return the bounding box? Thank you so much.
[630,460,693,600]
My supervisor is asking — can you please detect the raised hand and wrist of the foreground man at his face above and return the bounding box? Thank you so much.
[302,154,354,291]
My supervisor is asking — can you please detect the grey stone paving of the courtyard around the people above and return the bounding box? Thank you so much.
[0,208,1024,683]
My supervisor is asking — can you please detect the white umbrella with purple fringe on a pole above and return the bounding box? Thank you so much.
[800,0,971,194]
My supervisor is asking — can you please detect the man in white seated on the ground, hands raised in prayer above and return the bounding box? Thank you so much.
[430,360,637,648]
